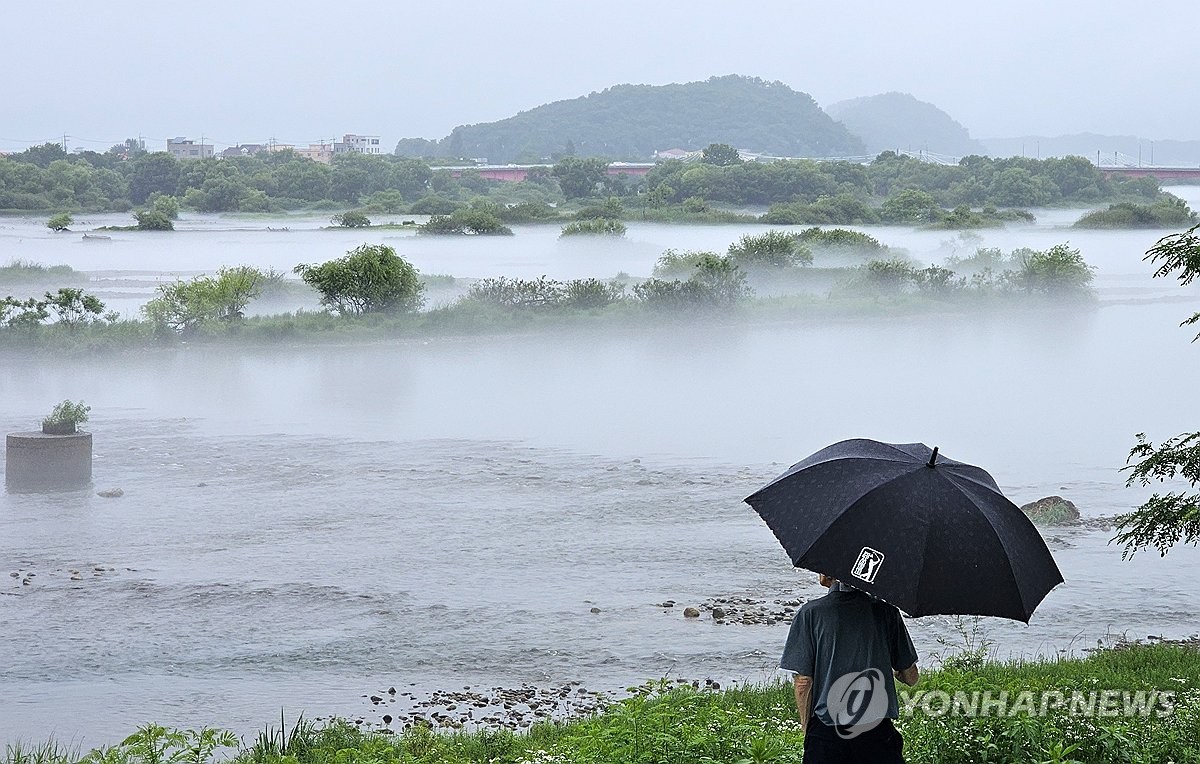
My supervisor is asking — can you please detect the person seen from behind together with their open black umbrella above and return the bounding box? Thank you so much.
[746,438,1062,764]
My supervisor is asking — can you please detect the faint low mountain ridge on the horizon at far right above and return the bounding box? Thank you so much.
[983,133,1200,167]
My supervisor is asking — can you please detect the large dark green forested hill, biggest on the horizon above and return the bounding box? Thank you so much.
[396,74,864,163]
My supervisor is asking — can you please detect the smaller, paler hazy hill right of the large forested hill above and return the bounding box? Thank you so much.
[826,92,984,157]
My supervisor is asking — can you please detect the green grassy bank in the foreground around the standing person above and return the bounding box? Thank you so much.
[0,644,1200,764]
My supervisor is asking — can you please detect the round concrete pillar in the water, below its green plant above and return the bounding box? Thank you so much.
[5,432,91,493]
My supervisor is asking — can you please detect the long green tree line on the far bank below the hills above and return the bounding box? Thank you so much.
[0,144,1166,219]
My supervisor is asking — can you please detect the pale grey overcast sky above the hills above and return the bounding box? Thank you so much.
[0,0,1200,150]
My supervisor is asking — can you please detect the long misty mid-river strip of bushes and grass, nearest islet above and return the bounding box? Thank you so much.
[0,235,1092,348]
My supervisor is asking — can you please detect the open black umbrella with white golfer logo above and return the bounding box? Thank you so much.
[746,439,1062,622]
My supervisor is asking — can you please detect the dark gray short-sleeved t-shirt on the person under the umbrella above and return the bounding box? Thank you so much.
[779,584,917,726]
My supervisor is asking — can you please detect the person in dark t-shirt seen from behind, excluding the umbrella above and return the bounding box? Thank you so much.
[780,574,919,764]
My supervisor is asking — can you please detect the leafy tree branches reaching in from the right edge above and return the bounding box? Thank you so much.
[1112,220,1200,559]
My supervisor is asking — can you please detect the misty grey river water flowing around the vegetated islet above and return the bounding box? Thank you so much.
[0,188,1200,746]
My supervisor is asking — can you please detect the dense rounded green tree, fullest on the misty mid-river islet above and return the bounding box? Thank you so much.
[295,245,425,315]
